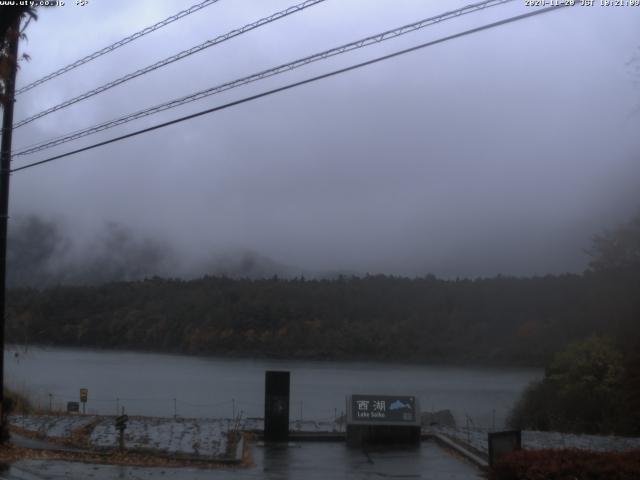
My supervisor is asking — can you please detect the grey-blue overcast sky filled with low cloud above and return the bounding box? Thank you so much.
[10,0,640,277]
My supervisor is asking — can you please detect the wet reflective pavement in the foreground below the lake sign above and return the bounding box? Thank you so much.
[5,441,482,480]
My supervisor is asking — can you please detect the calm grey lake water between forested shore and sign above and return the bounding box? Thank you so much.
[5,347,543,428]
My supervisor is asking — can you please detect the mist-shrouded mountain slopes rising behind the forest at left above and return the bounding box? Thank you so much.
[7,215,360,288]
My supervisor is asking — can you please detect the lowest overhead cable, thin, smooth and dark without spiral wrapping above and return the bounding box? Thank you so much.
[11,4,568,173]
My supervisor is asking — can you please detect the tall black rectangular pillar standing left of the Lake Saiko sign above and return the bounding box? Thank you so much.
[264,371,290,442]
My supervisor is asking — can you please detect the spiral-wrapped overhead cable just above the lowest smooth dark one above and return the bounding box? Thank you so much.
[14,0,513,157]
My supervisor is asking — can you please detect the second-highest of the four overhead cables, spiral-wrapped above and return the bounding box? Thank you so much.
[13,0,325,128]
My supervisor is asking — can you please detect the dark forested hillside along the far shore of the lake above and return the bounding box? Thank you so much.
[7,269,640,365]
